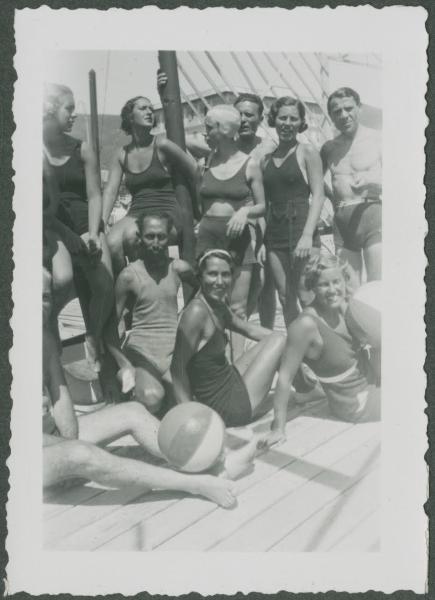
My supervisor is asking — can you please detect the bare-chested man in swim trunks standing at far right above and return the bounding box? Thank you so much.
[321,88,382,283]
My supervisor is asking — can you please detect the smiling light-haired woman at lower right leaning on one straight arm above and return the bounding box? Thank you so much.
[274,254,380,446]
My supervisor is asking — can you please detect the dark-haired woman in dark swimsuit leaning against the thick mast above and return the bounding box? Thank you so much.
[103,96,197,273]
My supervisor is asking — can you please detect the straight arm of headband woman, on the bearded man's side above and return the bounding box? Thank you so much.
[171,302,207,404]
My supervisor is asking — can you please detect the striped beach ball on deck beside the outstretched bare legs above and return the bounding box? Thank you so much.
[157,402,225,473]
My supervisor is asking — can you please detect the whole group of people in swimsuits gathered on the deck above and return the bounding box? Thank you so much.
[43,73,382,506]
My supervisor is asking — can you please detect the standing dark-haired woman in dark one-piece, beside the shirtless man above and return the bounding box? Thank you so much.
[261,96,324,325]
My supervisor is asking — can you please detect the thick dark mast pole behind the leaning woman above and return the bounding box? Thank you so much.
[159,50,195,299]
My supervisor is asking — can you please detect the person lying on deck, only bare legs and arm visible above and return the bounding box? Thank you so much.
[42,269,268,508]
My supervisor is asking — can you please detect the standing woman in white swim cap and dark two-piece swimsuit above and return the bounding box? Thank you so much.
[196,104,265,359]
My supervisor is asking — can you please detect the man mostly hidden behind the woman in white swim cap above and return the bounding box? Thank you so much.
[157,71,277,329]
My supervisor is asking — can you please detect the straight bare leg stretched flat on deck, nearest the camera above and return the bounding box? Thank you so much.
[43,440,235,508]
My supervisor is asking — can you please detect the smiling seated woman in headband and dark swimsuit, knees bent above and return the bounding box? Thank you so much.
[171,250,285,427]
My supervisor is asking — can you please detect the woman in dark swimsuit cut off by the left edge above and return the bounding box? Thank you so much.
[43,84,126,380]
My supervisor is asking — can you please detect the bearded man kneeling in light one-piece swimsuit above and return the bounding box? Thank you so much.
[115,213,198,414]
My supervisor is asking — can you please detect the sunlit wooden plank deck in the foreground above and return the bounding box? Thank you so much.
[44,288,380,552]
